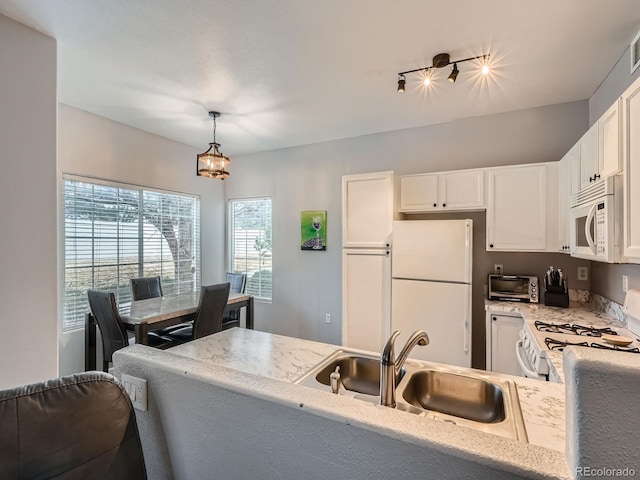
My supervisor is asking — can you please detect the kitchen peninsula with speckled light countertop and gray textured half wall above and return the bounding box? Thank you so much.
[114,328,572,479]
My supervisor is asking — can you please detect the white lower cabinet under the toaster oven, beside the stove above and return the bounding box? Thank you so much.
[487,312,524,376]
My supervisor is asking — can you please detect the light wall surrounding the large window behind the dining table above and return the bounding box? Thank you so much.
[58,104,226,375]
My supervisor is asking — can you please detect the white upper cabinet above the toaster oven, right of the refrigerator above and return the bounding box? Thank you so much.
[487,162,558,252]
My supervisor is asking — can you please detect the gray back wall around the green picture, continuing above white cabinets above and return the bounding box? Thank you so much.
[226,101,588,344]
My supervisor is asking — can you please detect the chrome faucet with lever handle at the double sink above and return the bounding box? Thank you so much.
[380,330,429,408]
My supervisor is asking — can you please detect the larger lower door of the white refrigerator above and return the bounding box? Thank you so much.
[391,279,471,367]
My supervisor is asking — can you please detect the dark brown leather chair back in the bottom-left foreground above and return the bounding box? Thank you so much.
[0,372,147,480]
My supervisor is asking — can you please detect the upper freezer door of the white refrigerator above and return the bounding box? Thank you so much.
[392,219,473,283]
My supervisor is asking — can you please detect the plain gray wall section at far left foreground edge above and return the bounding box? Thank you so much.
[0,15,58,389]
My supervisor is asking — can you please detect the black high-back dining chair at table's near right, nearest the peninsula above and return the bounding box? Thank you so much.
[165,283,230,345]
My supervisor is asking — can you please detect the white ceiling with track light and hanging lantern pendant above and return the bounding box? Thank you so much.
[0,0,640,156]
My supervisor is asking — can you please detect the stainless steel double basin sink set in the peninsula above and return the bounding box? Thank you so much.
[296,351,527,442]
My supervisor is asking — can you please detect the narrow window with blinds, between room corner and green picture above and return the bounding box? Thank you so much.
[229,198,273,301]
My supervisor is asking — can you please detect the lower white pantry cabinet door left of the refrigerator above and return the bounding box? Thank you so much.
[342,249,391,352]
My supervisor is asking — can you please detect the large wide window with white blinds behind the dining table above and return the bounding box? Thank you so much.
[62,177,200,331]
